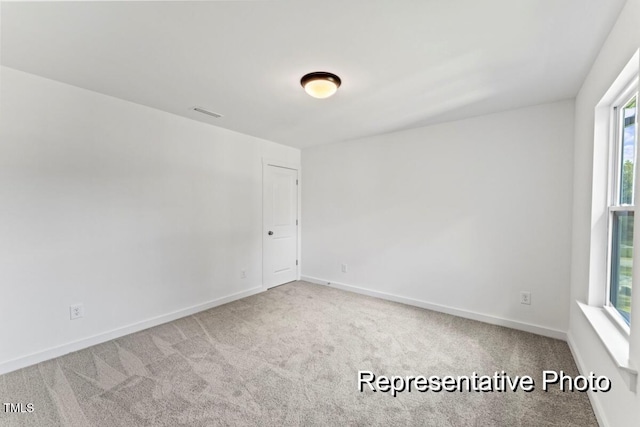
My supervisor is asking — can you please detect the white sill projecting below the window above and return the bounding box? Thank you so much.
[576,301,638,393]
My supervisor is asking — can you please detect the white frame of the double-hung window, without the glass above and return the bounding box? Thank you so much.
[604,80,640,336]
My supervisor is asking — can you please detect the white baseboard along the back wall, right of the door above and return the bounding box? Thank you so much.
[300,275,567,341]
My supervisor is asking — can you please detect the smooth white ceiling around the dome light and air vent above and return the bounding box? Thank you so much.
[1,0,624,148]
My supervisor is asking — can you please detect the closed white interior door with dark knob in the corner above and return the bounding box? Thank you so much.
[262,165,298,288]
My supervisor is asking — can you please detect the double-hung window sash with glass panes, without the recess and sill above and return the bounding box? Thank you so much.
[605,84,638,326]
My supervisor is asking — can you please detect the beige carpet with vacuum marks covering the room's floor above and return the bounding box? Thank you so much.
[0,282,597,427]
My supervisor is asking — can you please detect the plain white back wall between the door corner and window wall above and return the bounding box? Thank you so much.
[302,101,573,337]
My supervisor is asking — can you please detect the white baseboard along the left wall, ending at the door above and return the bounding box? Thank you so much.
[0,286,265,375]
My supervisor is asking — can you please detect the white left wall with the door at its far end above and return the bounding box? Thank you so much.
[0,68,300,372]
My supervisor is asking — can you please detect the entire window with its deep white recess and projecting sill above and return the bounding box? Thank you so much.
[576,49,640,393]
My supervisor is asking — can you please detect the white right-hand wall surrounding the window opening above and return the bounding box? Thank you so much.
[569,0,640,426]
